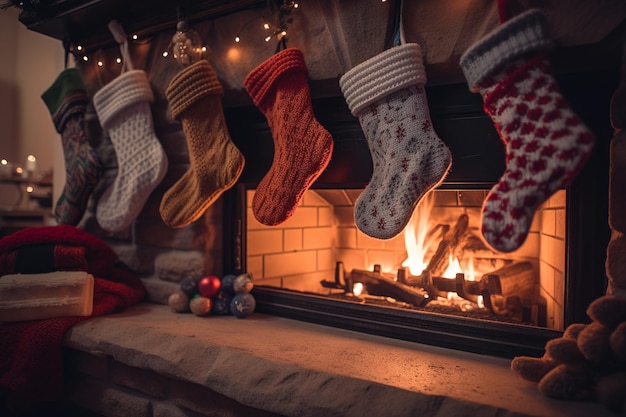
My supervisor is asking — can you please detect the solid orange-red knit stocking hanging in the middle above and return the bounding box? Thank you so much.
[244,48,334,226]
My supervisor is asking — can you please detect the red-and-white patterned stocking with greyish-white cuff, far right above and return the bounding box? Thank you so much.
[461,10,595,252]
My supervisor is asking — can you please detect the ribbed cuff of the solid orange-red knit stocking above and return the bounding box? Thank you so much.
[243,48,308,107]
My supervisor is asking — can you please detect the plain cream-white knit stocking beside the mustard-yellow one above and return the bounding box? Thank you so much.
[94,70,168,232]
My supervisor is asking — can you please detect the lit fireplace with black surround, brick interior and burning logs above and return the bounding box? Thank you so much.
[225,71,617,357]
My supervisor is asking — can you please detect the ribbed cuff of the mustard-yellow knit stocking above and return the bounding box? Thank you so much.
[165,60,224,119]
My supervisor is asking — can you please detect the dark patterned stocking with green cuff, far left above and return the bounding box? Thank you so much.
[41,68,102,226]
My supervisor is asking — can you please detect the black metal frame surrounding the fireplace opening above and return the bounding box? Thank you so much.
[224,62,618,357]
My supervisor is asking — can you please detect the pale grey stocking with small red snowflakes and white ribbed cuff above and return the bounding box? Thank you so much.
[339,43,452,239]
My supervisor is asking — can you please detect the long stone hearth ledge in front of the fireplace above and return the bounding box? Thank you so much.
[64,303,614,417]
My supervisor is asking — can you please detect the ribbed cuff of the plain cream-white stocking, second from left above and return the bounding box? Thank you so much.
[93,70,154,127]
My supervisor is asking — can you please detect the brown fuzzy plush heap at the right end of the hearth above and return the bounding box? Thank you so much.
[511,296,626,415]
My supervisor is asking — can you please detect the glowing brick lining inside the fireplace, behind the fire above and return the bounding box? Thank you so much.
[247,190,566,329]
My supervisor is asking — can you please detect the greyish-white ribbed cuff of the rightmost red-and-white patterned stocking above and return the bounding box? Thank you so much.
[460,9,552,91]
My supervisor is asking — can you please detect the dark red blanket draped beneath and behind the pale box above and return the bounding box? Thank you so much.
[0,225,145,404]
